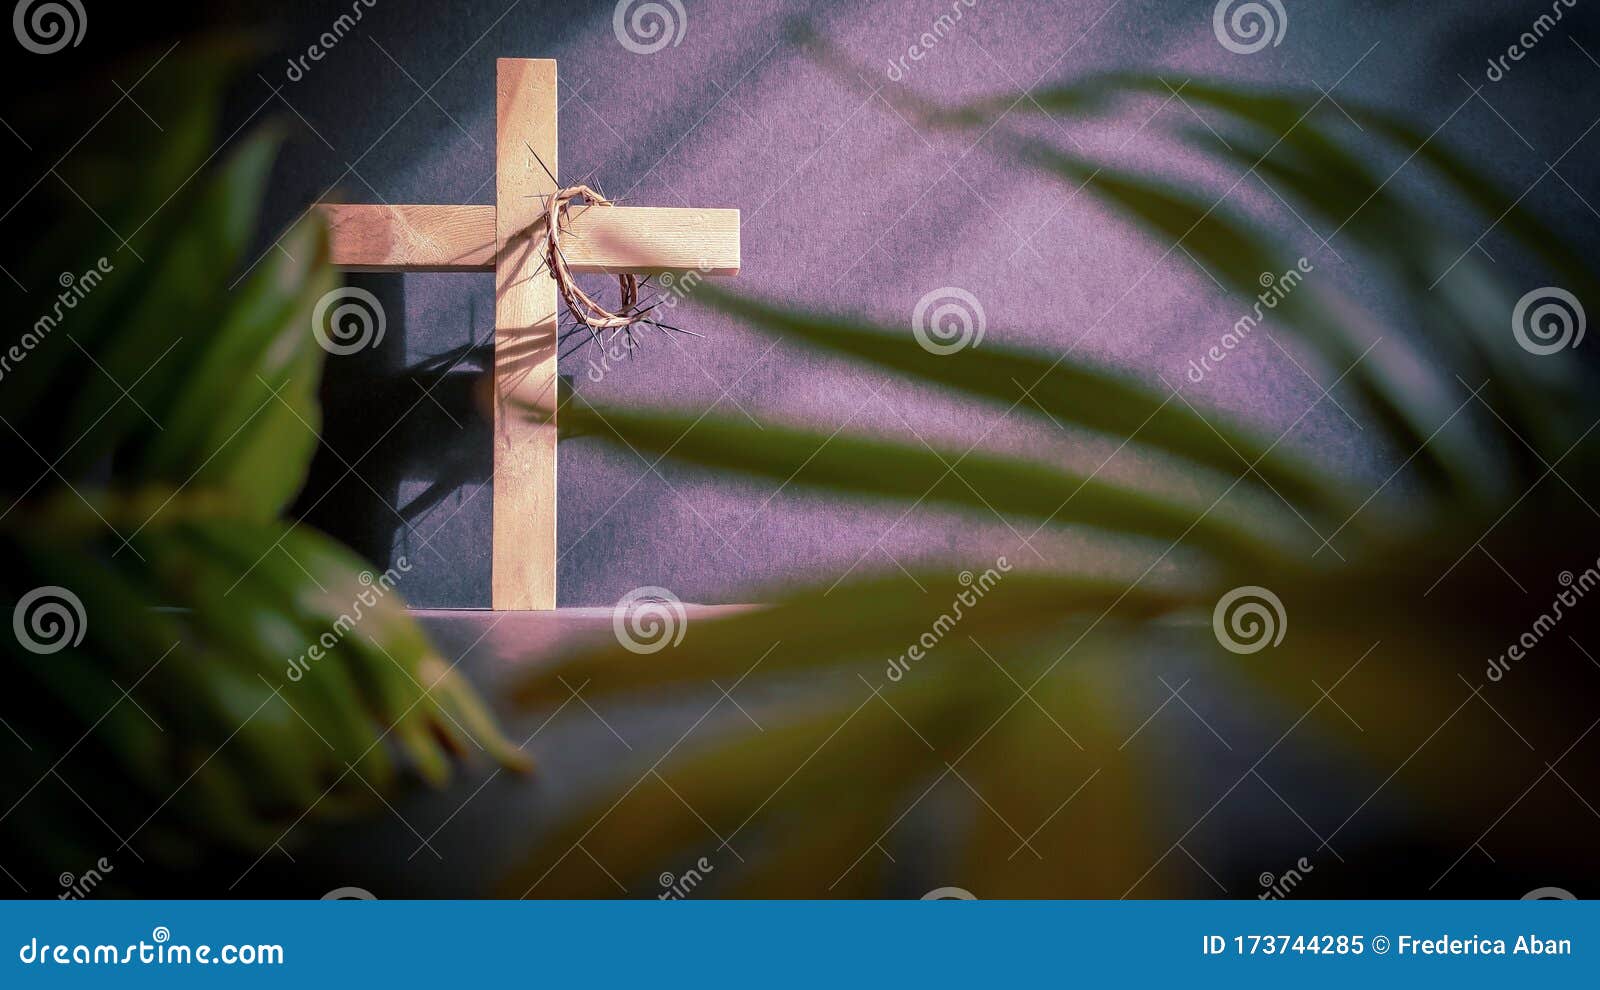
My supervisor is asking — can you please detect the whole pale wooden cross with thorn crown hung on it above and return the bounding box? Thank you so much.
[322,59,739,611]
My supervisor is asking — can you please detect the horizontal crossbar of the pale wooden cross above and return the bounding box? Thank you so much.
[322,202,739,275]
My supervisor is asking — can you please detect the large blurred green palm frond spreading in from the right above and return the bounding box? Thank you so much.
[506,74,1600,896]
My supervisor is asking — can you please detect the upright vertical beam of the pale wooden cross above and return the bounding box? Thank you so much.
[490,59,560,611]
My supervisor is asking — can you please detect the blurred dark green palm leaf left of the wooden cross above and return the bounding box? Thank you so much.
[0,42,525,891]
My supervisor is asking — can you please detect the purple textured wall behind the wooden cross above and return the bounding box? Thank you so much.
[259,0,1600,608]
